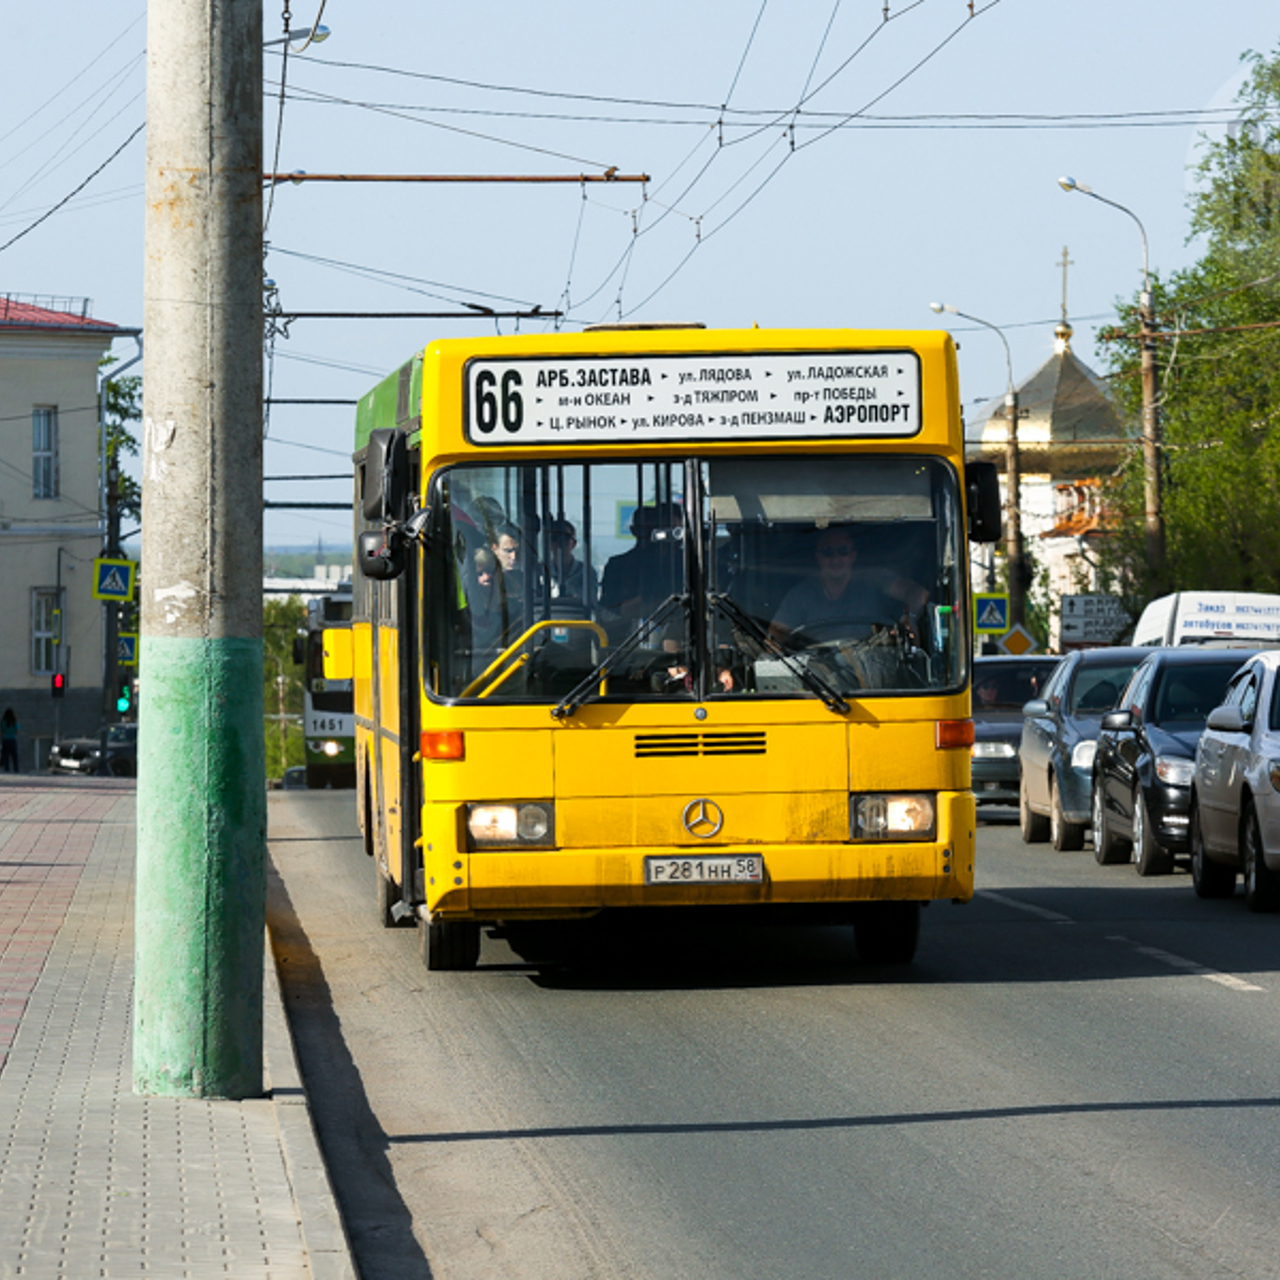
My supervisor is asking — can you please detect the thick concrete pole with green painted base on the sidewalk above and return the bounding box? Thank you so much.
[133,0,266,1098]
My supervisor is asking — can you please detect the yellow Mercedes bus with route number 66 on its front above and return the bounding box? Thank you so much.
[326,326,1000,969]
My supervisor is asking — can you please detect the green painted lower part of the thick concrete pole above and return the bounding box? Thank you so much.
[133,635,266,1098]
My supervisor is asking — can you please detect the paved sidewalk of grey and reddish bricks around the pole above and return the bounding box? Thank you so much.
[0,776,356,1280]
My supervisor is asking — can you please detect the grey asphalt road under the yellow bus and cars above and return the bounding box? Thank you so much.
[269,792,1280,1280]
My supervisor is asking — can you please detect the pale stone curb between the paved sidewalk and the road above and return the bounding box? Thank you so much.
[262,932,360,1280]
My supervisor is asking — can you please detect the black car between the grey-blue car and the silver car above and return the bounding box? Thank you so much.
[1093,645,1253,876]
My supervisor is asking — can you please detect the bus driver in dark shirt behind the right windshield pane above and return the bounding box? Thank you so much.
[769,525,929,648]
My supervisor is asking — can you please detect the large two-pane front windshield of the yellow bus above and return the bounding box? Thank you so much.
[422,453,965,703]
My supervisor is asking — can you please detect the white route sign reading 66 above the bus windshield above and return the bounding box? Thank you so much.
[465,351,920,445]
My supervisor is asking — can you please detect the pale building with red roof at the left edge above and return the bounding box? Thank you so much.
[0,294,128,771]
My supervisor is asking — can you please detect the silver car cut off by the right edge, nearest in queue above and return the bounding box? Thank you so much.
[1190,650,1280,911]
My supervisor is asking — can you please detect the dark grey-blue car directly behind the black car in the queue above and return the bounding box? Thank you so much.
[1018,648,1152,850]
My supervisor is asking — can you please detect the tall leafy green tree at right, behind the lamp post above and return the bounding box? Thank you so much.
[1106,50,1280,600]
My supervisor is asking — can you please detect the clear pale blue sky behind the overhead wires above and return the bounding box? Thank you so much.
[0,0,1280,544]
